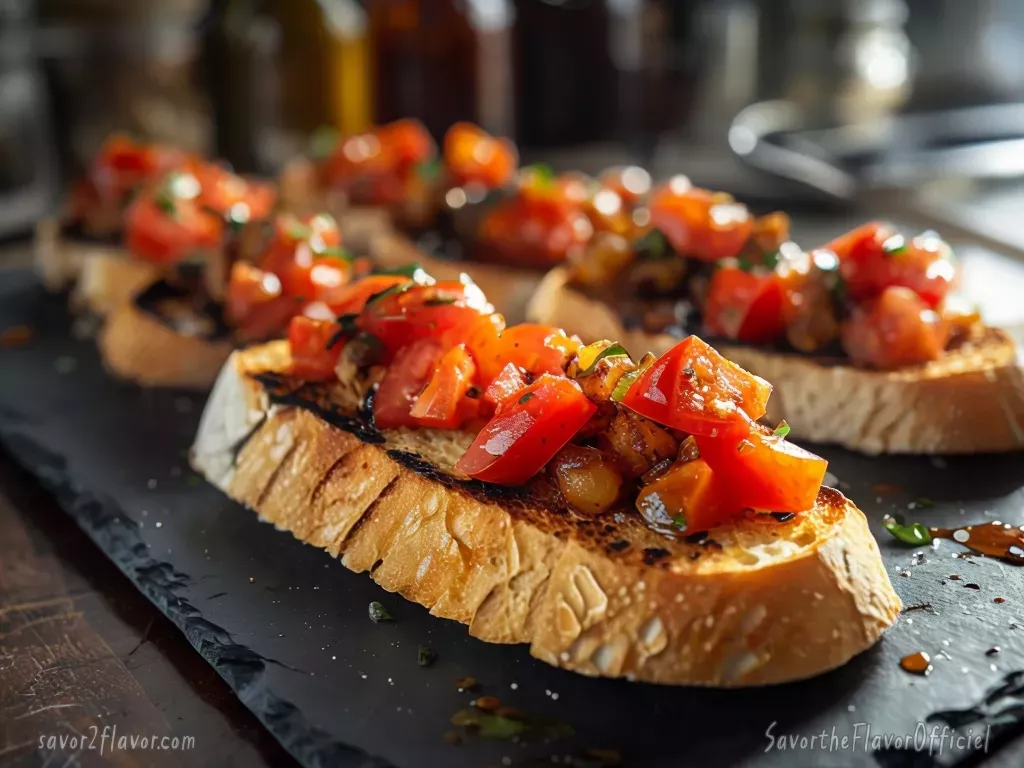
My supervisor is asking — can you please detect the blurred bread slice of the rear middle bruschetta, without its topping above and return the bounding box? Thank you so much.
[370,231,544,324]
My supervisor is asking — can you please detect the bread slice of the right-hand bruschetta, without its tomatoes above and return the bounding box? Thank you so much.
[527,268,1024,454]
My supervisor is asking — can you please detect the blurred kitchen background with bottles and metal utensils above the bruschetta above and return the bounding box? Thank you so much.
[6,0,1024,325]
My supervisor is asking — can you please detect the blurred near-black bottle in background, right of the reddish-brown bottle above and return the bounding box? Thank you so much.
[513,0,617,146]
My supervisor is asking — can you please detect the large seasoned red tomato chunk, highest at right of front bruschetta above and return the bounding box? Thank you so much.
[622,336,771,435]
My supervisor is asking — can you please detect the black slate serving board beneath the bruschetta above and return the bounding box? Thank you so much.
[0,271,1024,768]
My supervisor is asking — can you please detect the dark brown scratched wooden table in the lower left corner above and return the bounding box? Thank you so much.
[0,454,294,768]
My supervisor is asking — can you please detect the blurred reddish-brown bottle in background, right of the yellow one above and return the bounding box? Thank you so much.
[369,0,512,138]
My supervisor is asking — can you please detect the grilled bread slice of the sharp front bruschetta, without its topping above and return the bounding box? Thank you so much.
[191,342,900,686]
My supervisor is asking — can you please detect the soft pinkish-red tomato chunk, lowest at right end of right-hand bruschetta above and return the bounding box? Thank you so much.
[842,287,949,369]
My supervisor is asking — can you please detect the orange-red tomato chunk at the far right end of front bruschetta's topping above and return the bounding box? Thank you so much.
[696,422,828,512]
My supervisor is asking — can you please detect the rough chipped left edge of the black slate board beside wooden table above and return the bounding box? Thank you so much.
[0,423,396,768]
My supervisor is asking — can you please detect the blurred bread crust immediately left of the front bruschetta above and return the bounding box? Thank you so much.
[97,302,233,389]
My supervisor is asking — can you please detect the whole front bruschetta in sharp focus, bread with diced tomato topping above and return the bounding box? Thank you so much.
[191,273,900,686]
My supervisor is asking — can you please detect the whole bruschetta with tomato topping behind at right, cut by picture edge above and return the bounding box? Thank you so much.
[526,190,1024,454]
